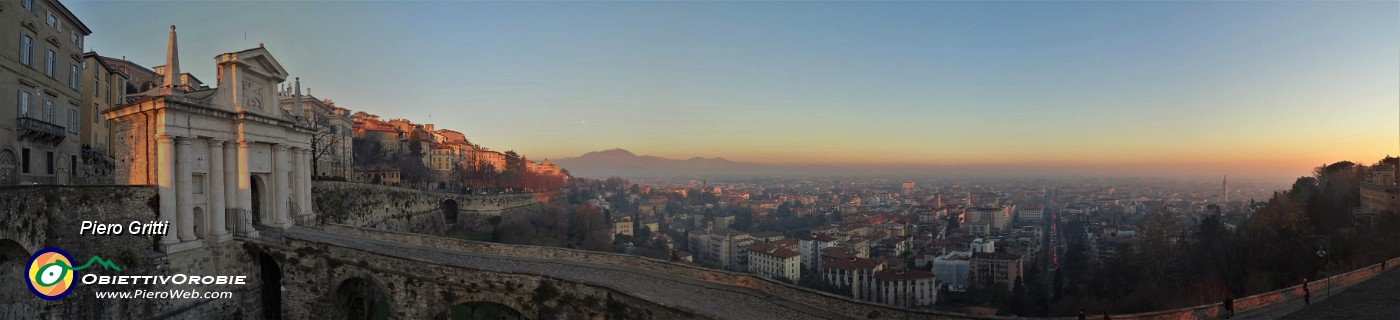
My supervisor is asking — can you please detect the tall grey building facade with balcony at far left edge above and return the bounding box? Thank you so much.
[0,0,92,184]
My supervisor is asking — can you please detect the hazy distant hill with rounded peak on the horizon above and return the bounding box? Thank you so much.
[553,148,780,177]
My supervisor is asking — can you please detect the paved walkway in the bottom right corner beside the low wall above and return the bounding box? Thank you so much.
[1233,270,1400,320]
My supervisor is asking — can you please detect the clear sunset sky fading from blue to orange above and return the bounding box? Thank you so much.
[66,1,1400,177]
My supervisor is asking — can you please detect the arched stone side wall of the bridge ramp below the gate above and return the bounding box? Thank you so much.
[259,230,696,319]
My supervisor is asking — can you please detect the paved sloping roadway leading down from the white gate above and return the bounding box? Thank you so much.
[286,228,850,319]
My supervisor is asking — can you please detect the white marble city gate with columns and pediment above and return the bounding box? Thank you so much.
[102,25,312,252]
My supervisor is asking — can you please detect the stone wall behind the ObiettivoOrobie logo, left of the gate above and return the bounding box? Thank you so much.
[0,186,260,319]
